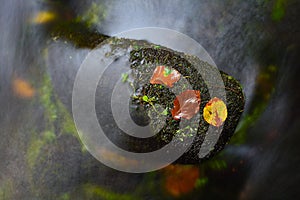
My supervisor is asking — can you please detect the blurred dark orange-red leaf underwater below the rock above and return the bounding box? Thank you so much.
[164,165,199,197]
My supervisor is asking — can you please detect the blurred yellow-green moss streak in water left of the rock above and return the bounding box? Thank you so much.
[26,72,80,169]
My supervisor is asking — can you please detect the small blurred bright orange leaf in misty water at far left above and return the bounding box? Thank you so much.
[12,78,35,99]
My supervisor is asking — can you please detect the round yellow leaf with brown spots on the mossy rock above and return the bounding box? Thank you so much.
[203,97,227,127]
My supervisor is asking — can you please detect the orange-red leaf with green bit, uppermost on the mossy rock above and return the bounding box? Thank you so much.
[150,66,180,87]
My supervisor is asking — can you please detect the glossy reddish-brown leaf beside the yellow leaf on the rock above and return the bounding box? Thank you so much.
[171,90,200,120]
